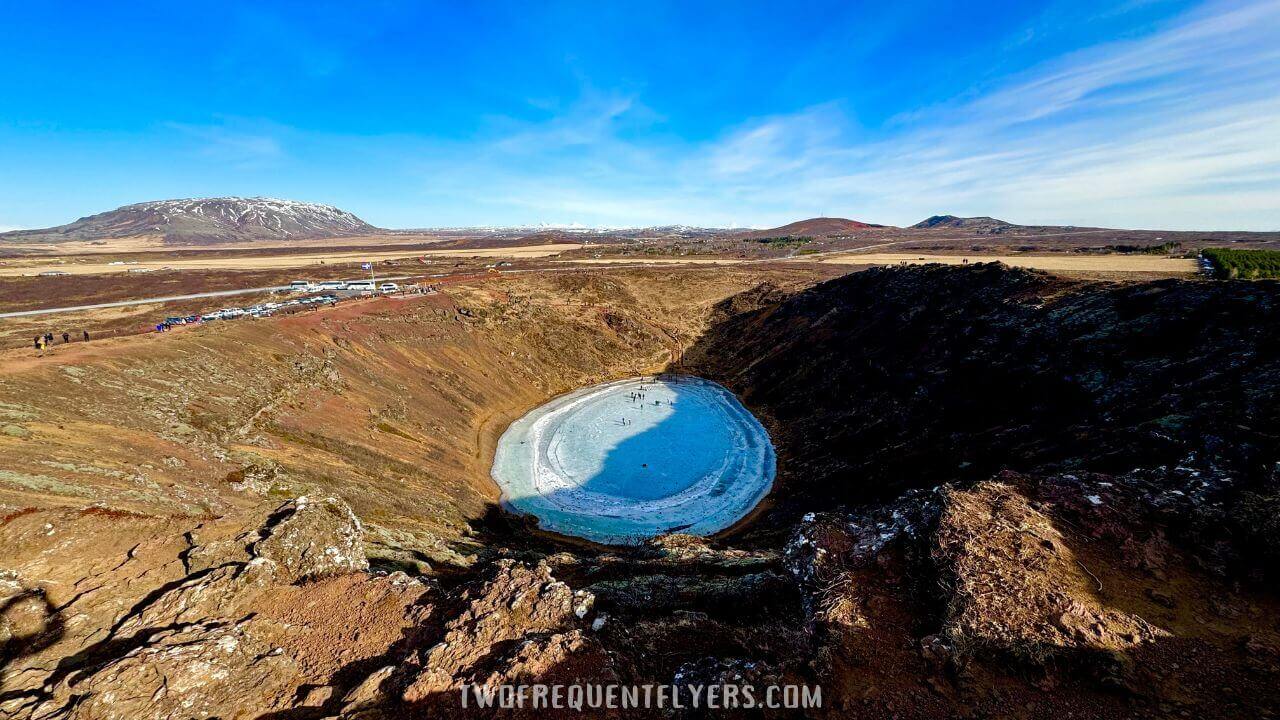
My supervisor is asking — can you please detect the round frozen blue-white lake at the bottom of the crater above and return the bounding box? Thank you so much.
[493,375,777,544]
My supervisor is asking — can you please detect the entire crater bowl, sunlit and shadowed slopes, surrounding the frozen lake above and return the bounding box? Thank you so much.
[0,264,1280,719]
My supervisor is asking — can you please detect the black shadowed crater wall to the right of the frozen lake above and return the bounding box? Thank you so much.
[685,263,1280,512]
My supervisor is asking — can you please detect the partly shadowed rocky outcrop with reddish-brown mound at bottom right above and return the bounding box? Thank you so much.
[780,473,1277,717]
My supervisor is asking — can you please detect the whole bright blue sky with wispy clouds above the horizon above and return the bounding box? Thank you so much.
[0,0,1280,229]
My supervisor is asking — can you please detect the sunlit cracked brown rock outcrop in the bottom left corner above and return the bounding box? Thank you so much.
[0,497,429,720]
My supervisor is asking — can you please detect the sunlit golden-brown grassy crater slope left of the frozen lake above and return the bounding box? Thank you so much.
[0,268,817,557]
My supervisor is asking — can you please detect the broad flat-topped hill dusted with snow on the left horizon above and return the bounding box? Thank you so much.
[0,197,378,245]
